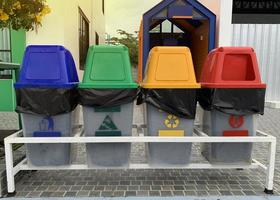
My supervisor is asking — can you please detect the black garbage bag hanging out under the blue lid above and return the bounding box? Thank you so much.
[16,88,78,116]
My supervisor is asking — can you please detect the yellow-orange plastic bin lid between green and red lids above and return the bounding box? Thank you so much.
[141,47,201,89]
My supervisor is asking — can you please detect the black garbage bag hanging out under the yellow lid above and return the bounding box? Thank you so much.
[137,89,197,119]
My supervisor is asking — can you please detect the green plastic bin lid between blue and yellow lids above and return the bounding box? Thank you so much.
[79,45,138,89]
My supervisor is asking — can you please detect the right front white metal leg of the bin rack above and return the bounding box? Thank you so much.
[264,138,276,194]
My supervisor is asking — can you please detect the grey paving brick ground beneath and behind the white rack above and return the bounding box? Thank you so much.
[0,107,280,197]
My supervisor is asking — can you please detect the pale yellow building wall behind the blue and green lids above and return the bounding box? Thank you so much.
[27,0,106,80]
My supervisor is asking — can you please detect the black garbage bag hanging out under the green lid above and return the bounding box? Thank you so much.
[79,88,139,108]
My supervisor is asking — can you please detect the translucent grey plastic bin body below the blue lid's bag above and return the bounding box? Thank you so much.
[21,113,72,166]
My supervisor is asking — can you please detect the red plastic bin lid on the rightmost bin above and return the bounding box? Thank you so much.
[200,47,266,88]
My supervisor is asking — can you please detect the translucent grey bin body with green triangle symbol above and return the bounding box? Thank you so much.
[83,103,133,168]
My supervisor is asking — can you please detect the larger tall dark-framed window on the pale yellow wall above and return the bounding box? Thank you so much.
[79,9,89,70]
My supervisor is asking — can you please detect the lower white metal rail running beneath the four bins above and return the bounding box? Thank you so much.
[20,163,259,170]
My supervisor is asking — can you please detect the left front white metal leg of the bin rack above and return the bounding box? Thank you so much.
[5,140,15,193]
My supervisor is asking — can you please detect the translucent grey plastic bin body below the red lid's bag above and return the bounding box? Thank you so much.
[202,110,256,165]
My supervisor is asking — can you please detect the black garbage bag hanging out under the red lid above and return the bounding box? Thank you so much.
[198,88,266,116]
